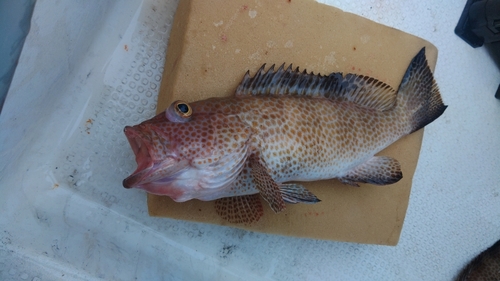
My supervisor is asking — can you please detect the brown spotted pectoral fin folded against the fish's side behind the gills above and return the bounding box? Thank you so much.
[249,157,285,213]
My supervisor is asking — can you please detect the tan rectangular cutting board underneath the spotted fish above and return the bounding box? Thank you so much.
[148,0,437,245]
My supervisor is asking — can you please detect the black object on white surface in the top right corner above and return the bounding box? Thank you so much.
[455,0,500,99]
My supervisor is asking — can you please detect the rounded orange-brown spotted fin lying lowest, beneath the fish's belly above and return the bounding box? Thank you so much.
[215,194,264,224]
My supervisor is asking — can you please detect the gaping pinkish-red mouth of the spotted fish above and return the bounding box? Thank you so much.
[123,126,177,188]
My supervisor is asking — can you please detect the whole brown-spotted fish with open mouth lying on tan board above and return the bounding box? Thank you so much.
[123,48,447,224]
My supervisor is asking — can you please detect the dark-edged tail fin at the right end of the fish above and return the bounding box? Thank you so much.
[396,47,447,133]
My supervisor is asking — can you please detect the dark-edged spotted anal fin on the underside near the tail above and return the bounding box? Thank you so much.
[340,156,403,186]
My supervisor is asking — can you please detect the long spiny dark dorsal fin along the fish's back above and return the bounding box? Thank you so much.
[235,64,396,111]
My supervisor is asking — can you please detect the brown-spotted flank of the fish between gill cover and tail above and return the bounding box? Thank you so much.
[188,97,411,182]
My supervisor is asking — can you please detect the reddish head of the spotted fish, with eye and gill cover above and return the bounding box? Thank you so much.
[123,102,249,202]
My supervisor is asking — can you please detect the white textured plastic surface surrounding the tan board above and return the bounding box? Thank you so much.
[0,0,500,281]
